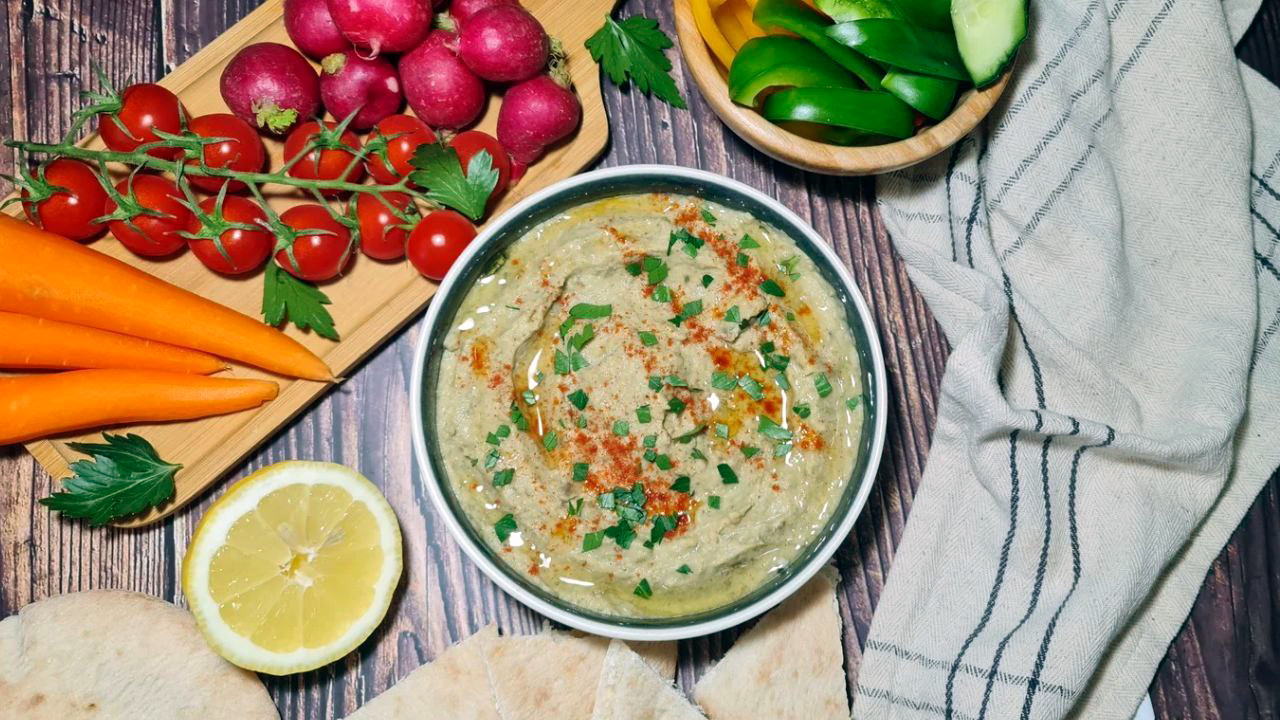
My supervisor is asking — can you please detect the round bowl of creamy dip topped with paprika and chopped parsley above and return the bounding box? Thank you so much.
[411,165,886,639]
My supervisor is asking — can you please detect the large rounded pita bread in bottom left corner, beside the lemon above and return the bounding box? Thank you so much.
[0,591,279,720]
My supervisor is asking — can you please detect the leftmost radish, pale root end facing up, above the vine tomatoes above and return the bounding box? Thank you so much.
[219,42,320,133]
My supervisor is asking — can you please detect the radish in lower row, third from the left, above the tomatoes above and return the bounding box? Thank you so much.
[399,29,489,129]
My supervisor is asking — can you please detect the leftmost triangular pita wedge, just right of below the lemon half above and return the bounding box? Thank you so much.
[348,625,499,720]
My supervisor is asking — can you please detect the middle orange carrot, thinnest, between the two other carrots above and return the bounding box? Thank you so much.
[0,313,227,375]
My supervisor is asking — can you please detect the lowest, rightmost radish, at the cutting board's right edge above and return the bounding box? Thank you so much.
[498,76,582,164]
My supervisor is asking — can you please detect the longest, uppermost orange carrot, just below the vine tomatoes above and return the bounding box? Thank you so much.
[0,215,333,380]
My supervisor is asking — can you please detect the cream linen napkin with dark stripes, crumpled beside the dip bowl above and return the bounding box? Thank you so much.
[854,0,1280,720]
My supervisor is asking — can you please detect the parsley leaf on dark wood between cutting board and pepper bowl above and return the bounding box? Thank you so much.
[586,15,685,108]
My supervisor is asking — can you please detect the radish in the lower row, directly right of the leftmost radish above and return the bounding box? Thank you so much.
[320,50,404,129]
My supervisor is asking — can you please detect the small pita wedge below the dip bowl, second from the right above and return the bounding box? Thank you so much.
[591,641,704,720]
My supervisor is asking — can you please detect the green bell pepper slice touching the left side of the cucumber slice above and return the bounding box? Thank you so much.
[829,18,969,81]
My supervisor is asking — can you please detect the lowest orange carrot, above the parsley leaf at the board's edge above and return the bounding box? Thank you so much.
[0,370,279,445]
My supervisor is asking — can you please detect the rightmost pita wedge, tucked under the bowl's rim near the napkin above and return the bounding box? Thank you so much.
[694,568,849,720]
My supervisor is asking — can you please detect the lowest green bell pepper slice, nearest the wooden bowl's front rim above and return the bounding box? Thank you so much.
[760,87,915,138]
